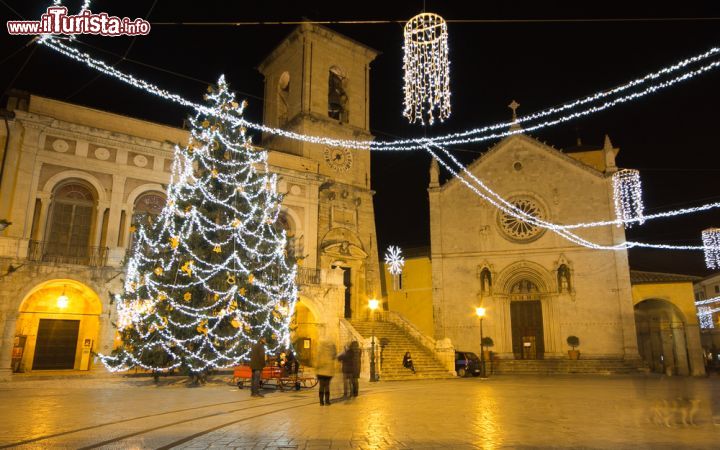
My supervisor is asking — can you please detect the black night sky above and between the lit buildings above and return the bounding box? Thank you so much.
[0,0,720,275]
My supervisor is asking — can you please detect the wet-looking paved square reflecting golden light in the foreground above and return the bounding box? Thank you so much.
[0,376,720,449]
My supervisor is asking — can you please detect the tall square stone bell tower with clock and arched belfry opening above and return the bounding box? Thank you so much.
[258,24,381,318]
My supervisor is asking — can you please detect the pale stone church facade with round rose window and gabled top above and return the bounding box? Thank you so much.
[428,128,703,374]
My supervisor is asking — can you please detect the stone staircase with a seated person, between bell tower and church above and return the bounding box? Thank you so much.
[351,320,452,381]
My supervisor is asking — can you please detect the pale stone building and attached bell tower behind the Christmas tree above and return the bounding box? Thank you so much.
[0,25,380,377]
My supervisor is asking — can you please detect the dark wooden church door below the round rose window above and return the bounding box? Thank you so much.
[510,300,545,359]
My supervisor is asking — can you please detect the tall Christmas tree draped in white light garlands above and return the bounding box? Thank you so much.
[102,77,297,377]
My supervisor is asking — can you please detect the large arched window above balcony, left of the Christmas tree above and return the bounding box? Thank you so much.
[44,181,95,263]
